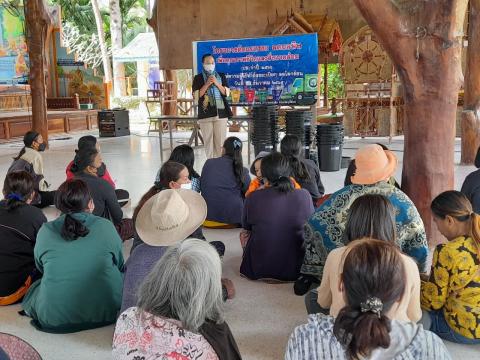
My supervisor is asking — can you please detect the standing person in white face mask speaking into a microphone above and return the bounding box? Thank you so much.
[192,54,232,159]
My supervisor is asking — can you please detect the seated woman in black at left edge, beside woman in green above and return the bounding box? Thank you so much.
[0,171,47,305]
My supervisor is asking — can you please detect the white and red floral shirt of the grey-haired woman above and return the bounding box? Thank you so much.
[113,307,218,360]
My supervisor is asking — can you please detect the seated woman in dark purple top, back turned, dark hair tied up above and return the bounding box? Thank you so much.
[240,153,314,281]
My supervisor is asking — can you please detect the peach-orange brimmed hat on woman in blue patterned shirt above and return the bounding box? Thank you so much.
[351,144,397,185]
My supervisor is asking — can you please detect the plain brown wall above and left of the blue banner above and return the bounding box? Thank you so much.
[156,0,364,69]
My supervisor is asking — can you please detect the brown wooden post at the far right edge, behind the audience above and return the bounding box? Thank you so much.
[461,0,480,164]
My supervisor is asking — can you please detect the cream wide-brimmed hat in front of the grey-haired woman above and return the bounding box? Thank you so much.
[135,189,207,246]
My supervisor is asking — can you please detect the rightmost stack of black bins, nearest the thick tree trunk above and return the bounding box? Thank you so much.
[317,123,344,171]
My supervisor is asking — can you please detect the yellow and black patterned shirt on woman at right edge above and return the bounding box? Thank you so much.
[421,236,480,339]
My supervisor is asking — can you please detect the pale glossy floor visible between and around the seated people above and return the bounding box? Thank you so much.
[0,134,480,360]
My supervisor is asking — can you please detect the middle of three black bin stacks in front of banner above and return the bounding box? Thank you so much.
[285,110,313,159]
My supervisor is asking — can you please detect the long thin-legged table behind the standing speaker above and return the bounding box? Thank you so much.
[150,115,251,164]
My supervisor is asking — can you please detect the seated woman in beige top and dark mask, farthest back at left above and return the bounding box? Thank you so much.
[7,131,55,208]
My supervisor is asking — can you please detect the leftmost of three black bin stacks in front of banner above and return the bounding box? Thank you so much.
[252,105,278,156]
